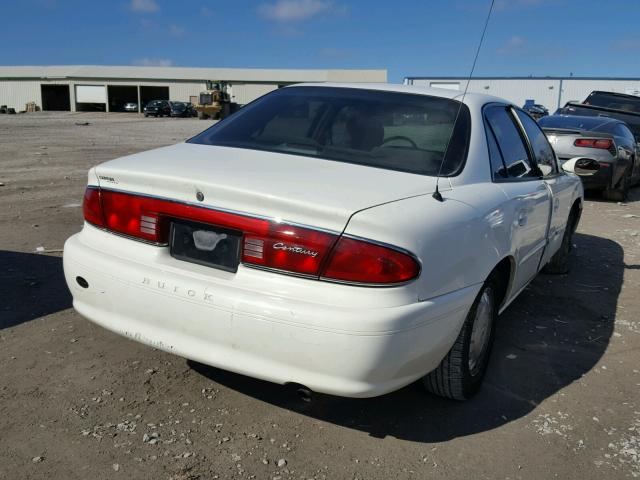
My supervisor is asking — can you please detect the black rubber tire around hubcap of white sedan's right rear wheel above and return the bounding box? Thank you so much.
[422,277,500,400]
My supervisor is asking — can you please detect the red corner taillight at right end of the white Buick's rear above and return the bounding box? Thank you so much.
[322,237,420,284]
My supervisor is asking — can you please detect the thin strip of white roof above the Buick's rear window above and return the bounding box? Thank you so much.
[286,82,512,106]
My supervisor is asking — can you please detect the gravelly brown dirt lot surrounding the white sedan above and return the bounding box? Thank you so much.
[0,113,640,480]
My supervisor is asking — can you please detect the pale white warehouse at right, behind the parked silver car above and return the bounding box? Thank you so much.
[404,77,640,113]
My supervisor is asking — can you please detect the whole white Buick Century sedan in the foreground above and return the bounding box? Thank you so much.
[64,84,590,399]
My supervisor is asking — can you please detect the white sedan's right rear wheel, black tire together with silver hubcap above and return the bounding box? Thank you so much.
[422,277,499,400]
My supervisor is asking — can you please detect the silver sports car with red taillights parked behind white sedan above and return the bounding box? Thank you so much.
[538,115,640,201]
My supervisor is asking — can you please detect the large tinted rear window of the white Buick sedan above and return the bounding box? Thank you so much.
[188,87,471,176]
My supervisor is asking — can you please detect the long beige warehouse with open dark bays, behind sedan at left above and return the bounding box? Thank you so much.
[0,65,387,112]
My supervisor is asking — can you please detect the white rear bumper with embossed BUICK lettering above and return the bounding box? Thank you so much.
[64,227,479,397]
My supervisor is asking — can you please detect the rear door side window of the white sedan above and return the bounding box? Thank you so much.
[484,105,538,179]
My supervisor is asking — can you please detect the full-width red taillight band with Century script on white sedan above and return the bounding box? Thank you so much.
[84,187,420,284]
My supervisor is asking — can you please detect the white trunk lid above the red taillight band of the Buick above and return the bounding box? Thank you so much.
[96,143,442,232]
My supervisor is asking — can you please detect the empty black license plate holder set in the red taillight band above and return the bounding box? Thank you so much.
[169,220,242,273]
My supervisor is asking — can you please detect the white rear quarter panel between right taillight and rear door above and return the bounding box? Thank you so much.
[346,184,510,300]
